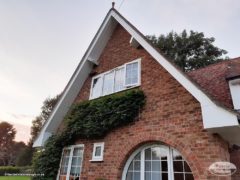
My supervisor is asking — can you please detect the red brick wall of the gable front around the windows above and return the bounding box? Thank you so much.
[70,26,229,180]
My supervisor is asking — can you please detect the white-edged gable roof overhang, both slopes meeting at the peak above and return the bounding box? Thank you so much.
[33,8,240,147]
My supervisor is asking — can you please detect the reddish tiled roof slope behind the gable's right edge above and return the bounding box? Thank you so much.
[188,57,240,109]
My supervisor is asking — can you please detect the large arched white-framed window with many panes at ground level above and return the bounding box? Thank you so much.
[122,144,194,180]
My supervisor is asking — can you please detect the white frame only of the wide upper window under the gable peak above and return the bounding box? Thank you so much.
[89,58,141,100]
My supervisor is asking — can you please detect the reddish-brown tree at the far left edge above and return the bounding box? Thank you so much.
[0,122,16,166]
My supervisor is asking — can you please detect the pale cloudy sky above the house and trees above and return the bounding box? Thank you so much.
[0,0,240,142]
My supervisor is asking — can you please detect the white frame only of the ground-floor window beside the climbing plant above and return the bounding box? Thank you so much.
[57,144,84,180]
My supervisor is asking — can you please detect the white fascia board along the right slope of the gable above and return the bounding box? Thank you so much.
[112,12,239,129]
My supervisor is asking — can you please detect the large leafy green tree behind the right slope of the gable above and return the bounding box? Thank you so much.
[147,30,228,71]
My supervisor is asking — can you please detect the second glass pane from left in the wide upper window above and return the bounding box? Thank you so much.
[103,71,114,95]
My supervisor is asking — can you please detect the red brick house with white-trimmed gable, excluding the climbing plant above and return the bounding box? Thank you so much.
[34,8,240,180]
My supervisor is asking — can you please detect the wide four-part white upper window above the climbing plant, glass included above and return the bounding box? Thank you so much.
[90,59,141,99]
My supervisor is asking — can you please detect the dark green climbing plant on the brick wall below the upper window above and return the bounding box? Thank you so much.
[34,90,145,179]
